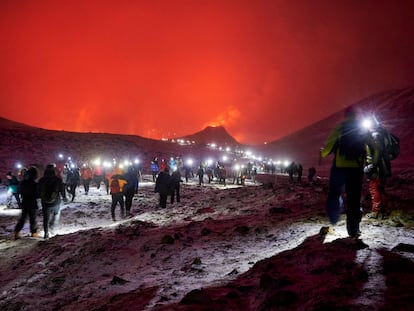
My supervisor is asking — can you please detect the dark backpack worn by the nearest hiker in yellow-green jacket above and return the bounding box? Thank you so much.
[337,120,367,161]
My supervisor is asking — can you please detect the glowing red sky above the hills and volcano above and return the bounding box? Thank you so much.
[0,0,414,144]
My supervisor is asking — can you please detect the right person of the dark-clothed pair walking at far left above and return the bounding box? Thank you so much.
[38,164,63,239]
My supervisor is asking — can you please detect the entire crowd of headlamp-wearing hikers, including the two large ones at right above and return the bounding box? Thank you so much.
[6,107,399,243]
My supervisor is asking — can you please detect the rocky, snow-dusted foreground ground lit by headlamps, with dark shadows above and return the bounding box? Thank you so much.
[0,175,414,310]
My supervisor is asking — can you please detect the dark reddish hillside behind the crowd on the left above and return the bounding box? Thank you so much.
[0,118,210,177]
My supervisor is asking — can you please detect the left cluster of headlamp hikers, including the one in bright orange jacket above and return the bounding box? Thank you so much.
[6,163,140,239]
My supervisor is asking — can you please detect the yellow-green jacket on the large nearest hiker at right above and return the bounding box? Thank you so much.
[321,118,378,168]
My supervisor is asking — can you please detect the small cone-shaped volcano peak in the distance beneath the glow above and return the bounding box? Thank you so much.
[179,126,240,147]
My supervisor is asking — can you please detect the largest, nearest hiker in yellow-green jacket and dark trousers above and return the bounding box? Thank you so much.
[320,106,378,238]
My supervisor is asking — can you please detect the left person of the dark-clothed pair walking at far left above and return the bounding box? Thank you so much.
[14,166,39,240]
